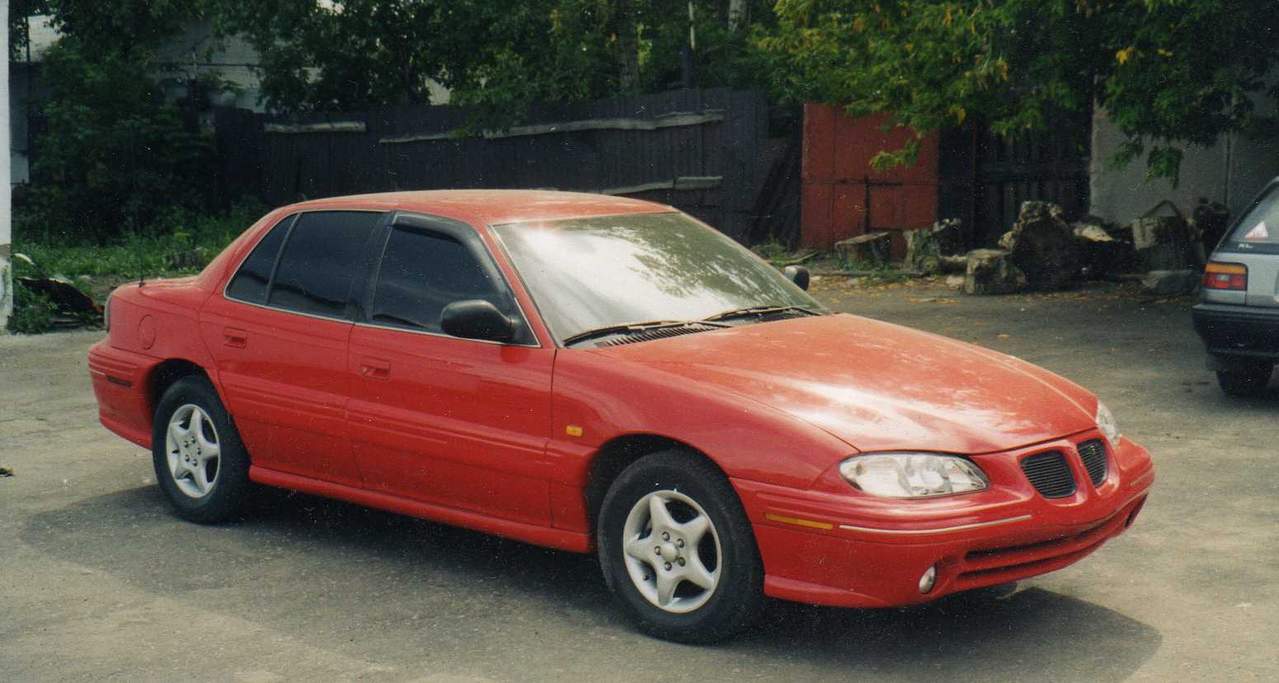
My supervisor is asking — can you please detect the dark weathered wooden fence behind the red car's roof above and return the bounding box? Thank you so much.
[215,88,798,242]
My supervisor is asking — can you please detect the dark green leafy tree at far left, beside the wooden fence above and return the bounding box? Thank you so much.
[10,0,215,239]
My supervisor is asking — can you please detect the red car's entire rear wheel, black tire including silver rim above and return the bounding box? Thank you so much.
[151,375,249,524]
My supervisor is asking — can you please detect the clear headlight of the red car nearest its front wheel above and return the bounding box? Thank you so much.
[839,453,986,498]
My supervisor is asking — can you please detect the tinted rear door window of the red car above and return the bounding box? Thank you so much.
[269,211,381,317]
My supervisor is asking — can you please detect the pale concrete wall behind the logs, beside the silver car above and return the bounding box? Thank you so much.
[1088,105,1279,224]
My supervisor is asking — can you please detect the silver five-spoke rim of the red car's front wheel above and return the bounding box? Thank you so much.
[622,491,724,614]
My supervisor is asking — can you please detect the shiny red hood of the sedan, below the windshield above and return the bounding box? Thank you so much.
[593,315,1096,454]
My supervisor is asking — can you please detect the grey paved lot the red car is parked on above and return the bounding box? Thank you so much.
[0,281,1279,680]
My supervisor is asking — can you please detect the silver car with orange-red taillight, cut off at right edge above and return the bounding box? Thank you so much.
[1193,178,1279,396]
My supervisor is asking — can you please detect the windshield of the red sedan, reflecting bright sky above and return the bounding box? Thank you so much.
[494,212,821,340]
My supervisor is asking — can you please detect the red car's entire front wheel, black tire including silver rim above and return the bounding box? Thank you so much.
[596,450,764,643]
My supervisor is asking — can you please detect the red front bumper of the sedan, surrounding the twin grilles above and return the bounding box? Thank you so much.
[733,432,1155,608]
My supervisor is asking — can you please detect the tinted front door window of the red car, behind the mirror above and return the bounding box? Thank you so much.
[370,228,498,331]
